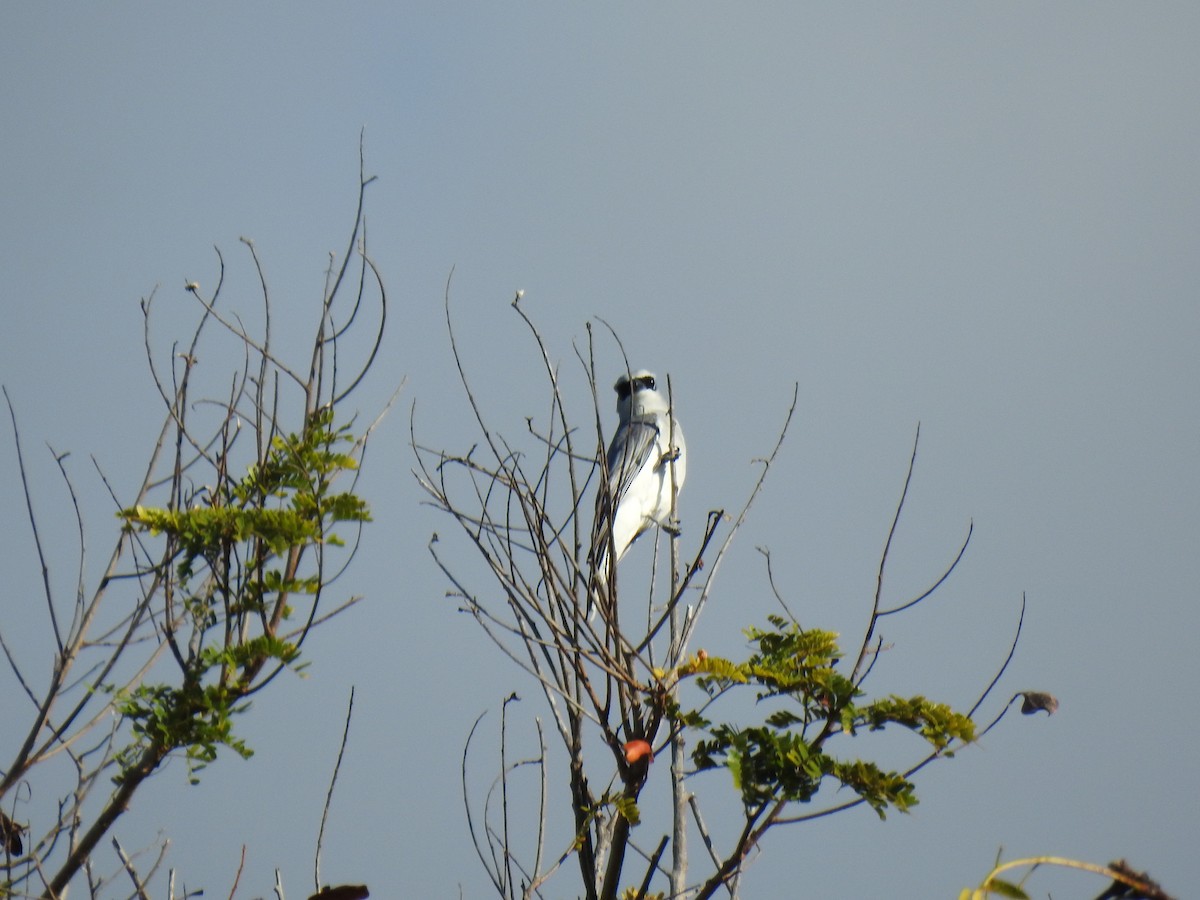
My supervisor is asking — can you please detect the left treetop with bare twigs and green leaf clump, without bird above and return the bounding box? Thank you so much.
[0,150,388,898]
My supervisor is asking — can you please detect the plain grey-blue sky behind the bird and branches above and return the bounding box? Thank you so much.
[0,2,1200,898]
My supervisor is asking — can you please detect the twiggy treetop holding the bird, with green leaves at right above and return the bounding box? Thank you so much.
[422,300,1051,900]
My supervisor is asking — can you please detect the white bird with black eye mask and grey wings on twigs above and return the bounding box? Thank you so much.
[588,368,688,614]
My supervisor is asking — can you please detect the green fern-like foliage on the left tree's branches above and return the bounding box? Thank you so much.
[114,408,371,784]
